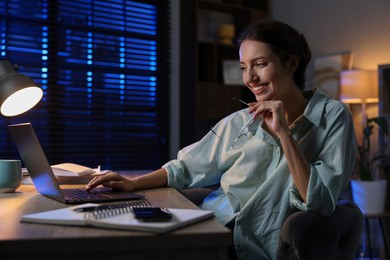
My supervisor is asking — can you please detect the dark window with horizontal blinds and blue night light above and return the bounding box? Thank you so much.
[0,0,169,170]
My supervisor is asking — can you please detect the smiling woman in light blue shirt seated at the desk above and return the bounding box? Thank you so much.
[87,20,356,259]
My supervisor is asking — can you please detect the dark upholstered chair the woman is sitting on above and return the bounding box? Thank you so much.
[181,188,363,260]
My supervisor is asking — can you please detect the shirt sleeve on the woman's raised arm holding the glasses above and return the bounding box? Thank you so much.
[290,101,357,216]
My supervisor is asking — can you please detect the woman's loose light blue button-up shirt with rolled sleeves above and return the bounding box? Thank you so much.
[163,90,357,259]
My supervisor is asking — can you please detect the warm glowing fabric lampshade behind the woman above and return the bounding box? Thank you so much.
[340,70,378,103]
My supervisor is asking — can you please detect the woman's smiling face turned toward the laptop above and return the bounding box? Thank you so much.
[239,40,296,101]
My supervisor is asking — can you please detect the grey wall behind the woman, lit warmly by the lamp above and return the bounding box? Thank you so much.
[269,0,390,88]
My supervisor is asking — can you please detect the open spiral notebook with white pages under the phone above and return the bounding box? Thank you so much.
[20,199,214,234]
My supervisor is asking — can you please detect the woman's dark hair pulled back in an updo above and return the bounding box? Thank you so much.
[237,19,311,90]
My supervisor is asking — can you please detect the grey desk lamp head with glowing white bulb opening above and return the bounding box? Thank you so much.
[0,60,43,116]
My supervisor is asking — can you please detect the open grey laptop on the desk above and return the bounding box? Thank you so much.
[8,123,144,204]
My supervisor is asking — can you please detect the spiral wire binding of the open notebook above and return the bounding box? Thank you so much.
[84,199,151,219]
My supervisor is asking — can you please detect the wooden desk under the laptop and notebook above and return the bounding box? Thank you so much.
[0,182,232,260]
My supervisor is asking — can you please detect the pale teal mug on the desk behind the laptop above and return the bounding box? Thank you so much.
[0,159,22,193]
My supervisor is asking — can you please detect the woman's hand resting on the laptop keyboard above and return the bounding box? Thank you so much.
[85,172,134,191]
